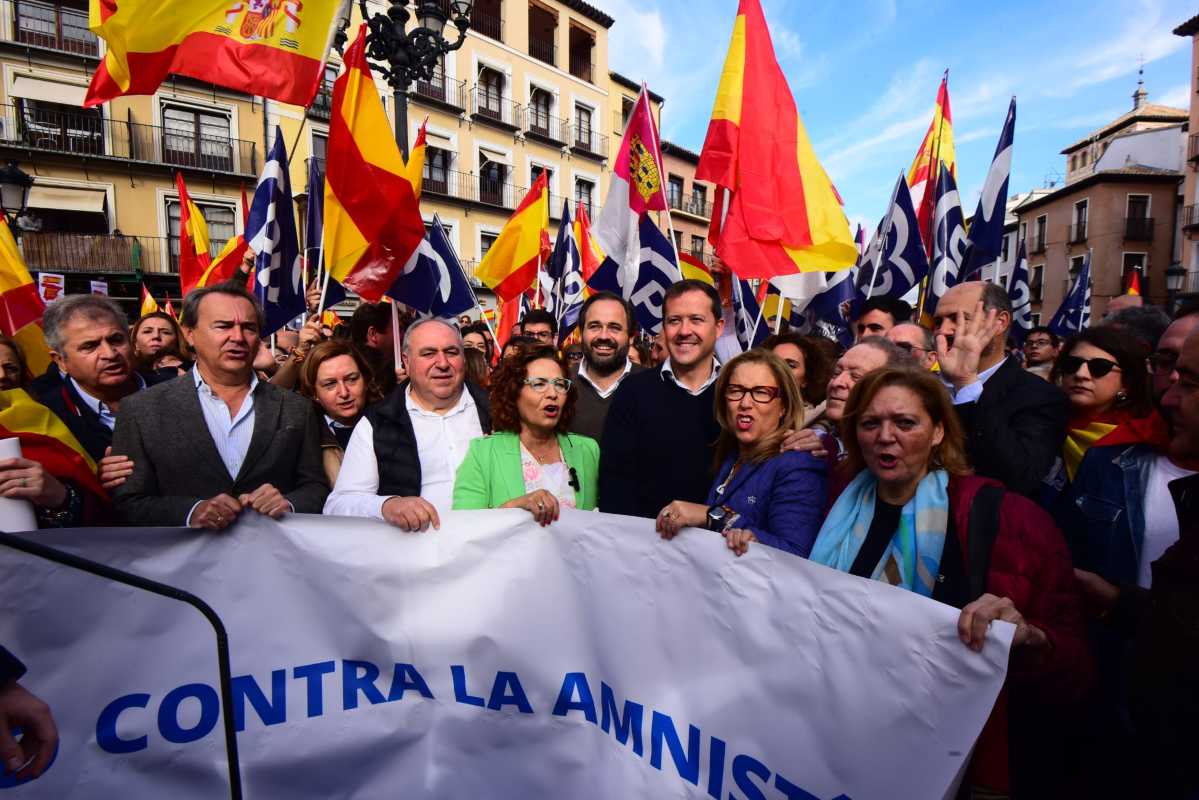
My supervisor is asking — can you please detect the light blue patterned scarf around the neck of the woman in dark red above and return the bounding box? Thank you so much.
[808,469,950,597]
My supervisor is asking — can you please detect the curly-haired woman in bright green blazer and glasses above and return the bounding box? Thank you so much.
[453,347,600,525]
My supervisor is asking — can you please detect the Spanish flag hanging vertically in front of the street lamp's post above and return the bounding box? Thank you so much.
[324,25,424,302]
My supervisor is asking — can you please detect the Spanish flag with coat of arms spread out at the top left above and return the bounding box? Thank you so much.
[84,0,347,106]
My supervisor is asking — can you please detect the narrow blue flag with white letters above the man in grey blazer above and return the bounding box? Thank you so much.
[246,126,305,336]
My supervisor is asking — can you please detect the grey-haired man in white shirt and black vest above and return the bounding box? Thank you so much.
[325,319,492,531]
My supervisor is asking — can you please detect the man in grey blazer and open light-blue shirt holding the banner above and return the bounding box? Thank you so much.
[113,283,329,530]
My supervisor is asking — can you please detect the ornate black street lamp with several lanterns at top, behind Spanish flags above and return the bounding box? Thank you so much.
[359,0,475,161]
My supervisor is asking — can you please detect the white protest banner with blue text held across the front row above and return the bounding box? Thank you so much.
[0,510,1013,800]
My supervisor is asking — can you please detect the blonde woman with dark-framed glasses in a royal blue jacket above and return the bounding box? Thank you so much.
[656,350,827,558]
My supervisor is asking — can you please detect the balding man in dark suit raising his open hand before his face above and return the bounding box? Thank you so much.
[933,281,1068,497]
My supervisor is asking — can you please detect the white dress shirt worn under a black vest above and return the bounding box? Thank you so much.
[325,387,483,519]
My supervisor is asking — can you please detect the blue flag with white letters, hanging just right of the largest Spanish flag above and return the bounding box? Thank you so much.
[857,174,928,300]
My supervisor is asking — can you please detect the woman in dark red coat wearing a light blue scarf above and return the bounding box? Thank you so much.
[809,368,1091,796]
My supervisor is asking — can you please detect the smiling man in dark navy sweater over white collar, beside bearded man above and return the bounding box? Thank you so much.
[600,279,724,518]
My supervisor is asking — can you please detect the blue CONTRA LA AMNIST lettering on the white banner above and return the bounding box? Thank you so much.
[88,660,850,800]
